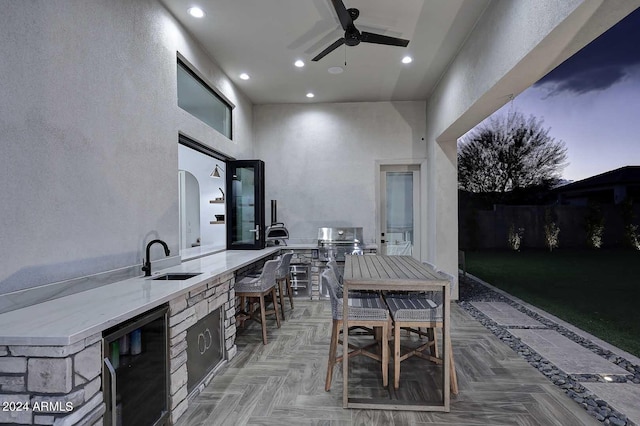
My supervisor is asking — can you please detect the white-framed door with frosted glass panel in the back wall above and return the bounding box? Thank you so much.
[379,165,420,259]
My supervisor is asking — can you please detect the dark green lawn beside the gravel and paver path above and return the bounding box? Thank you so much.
[466,249,640,356]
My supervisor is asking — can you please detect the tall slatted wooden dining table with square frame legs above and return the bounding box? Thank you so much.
[342,255,451,412]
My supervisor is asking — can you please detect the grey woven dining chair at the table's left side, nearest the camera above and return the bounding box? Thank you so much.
[321,268,390,392]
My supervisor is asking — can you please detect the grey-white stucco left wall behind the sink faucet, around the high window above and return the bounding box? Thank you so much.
[0,0,253,293]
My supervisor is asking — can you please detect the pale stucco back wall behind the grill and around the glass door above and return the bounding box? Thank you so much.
[253,102,426,243]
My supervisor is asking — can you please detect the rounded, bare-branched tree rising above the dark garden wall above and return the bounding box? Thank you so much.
[458,111,567,193]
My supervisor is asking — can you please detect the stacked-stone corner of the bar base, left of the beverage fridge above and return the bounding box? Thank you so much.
[0,333,105,426]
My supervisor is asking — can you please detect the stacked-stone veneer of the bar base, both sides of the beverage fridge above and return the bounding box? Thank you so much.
[0,272,237,426]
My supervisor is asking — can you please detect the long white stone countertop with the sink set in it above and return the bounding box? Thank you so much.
[0,245,280,346]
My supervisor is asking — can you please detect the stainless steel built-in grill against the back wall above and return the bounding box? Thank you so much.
[318,227,364,262]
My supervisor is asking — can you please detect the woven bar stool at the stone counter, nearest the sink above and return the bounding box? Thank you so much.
[235,260,280,345]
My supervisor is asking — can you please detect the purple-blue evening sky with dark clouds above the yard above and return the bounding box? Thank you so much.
[476,9,640,180]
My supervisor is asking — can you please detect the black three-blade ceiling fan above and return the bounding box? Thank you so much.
[312,0,409,62]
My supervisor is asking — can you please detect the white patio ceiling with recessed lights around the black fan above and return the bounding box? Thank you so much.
[162,0,489,104]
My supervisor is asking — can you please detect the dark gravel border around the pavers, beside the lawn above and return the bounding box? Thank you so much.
[457,276,640,426]
